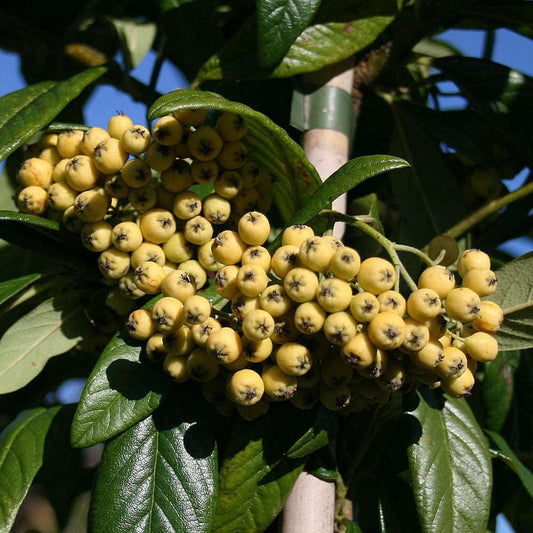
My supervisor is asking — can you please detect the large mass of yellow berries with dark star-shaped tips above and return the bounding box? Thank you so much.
[12,109,503,420]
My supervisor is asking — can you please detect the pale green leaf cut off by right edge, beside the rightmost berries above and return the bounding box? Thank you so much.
[487,252,533,351]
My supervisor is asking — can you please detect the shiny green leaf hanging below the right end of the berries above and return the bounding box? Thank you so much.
[408,391,492,533]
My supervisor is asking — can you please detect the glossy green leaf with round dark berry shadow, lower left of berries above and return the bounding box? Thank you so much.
[71,332,172,447]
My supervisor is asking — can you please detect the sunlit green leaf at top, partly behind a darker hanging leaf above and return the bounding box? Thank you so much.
[196,11,393,82]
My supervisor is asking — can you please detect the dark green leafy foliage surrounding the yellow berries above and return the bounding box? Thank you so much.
[0,0,533,533]
